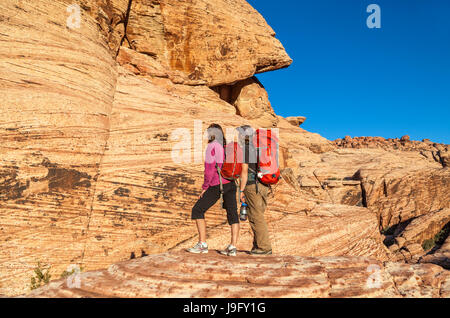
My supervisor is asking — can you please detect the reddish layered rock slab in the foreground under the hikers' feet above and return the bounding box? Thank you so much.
[27,252,450,298]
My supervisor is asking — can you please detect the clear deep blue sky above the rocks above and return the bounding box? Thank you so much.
[248,0,450,144]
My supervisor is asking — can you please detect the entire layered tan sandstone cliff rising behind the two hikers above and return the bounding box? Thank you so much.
[0,0,450,296]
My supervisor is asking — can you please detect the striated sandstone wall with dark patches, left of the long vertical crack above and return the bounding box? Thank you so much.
[0,0,117,295]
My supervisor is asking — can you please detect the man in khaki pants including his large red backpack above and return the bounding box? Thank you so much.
[237,125,280,255]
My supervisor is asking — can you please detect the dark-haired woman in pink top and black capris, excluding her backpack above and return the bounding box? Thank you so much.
[188,124,239,256]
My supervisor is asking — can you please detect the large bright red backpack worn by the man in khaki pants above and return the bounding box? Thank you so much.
[253,129,281,185]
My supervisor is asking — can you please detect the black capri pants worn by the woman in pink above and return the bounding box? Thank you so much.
[192,182,239,225]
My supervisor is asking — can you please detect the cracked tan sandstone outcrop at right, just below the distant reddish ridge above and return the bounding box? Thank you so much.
[288,148,449,214]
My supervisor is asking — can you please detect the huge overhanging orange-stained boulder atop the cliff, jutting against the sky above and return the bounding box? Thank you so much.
[124,0,292,86]
